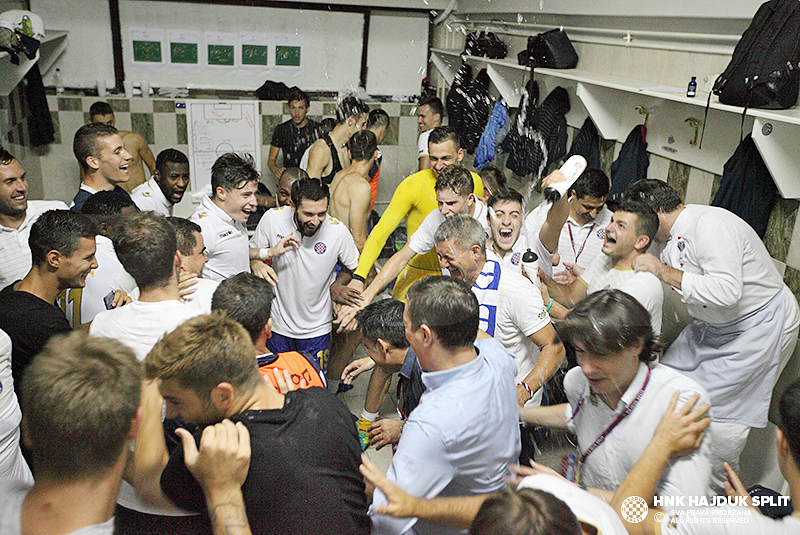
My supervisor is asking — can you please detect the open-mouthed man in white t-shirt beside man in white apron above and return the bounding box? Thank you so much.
[542,193,664,333]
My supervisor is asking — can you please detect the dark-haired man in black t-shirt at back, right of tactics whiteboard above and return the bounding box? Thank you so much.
[267,87,319,180]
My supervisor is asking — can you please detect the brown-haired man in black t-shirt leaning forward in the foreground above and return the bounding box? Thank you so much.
[134,313,370,535]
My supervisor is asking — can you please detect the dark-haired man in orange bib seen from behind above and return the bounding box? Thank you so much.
[211,273,325,389]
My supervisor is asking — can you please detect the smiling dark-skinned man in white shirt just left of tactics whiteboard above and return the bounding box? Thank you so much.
[131,149,189,217]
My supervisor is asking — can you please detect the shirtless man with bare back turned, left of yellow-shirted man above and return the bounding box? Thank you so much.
[328,130,378,253]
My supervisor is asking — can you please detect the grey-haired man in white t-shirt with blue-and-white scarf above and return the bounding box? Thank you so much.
[434,214,564,406]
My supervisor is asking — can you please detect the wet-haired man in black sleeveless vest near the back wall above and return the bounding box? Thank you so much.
[306,96,369,184]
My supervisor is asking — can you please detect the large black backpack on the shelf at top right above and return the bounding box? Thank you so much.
[712,0,800,110]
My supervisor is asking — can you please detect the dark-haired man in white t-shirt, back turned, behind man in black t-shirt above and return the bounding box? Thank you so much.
[89,212,201,533]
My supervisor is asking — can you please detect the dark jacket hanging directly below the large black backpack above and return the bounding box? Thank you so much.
[711,134,778,238]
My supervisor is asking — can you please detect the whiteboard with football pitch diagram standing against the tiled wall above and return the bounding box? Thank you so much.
[186,100,261,197]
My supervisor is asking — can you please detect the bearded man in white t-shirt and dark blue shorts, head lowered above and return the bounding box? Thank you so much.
[251,178,358,372]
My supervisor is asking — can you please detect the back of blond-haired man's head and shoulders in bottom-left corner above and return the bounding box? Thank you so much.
[0,332,143,535]
